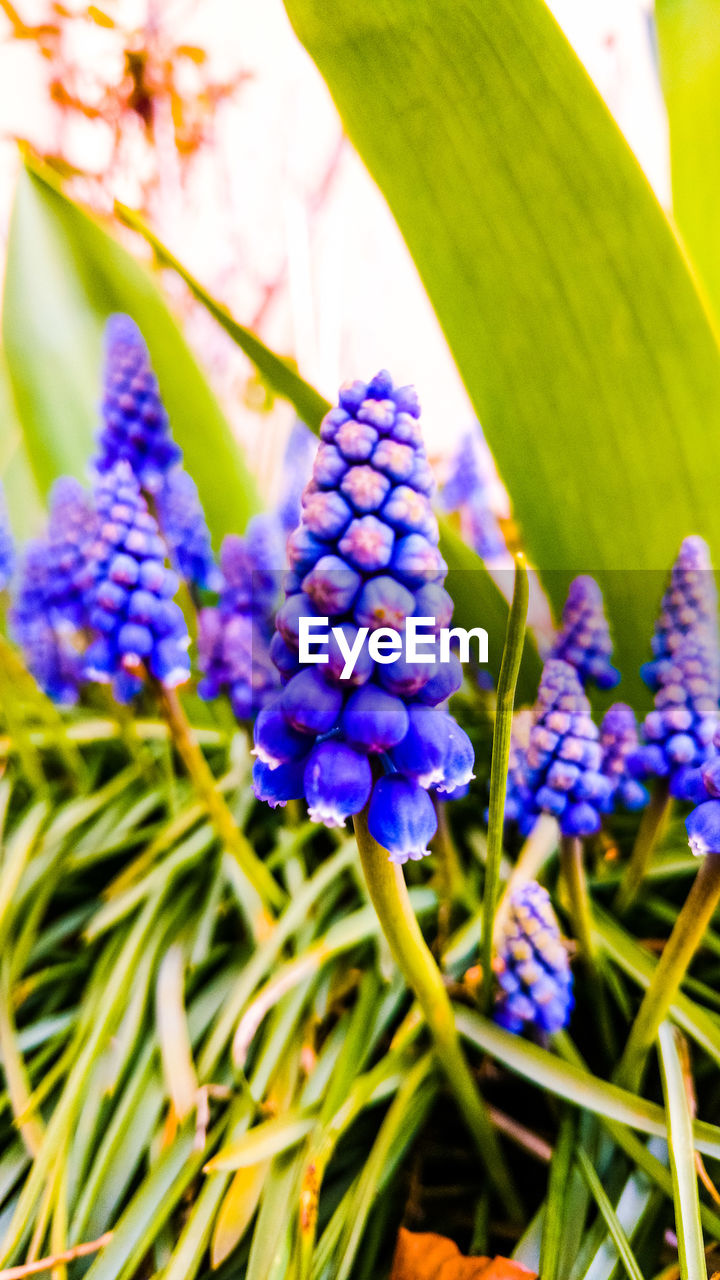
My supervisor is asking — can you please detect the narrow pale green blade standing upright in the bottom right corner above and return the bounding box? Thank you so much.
[659,1023,707,1280]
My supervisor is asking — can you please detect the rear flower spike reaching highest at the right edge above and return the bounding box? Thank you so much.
[641,536,717,691]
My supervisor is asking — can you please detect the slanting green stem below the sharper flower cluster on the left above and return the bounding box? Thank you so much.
[158,686,284,937]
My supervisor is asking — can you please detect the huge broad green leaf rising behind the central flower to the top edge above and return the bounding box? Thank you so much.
[286,0,720,689]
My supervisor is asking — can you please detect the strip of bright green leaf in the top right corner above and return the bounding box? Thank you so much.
[655,0,720,320]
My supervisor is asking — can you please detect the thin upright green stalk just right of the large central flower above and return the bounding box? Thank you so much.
[480,554,529,1012]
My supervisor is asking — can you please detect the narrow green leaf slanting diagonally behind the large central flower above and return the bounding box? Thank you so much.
[115,205,539,701]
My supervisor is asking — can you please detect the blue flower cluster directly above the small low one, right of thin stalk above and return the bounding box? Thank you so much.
[527,658,610,836]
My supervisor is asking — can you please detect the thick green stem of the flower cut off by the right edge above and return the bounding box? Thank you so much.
[615,854,720,1093]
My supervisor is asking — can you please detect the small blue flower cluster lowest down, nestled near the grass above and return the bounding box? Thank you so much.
[493,881,574,1036]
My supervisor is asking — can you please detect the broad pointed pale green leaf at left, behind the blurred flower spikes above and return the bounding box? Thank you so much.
[3,169,258,540]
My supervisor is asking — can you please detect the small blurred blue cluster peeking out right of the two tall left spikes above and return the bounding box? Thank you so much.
[155,467,223,591]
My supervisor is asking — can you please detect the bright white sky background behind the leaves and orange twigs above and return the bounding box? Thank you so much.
[0,0,669,506]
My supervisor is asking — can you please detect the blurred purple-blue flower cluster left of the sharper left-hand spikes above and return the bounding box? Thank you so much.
[10,476,97,707]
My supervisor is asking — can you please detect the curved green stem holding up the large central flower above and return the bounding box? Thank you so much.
[354,813,520,1221]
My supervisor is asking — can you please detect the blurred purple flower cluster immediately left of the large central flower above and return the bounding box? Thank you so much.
[197,516,283,721]
